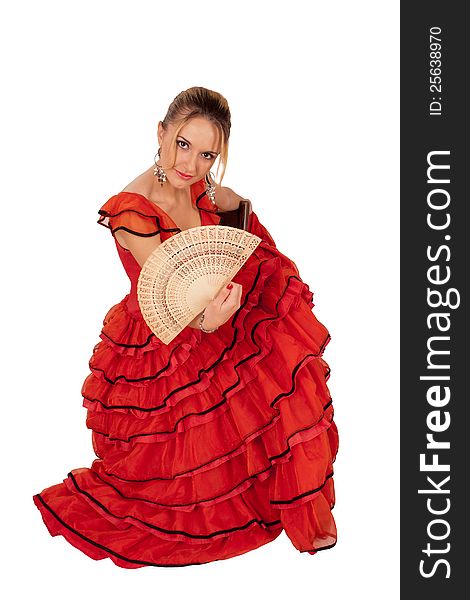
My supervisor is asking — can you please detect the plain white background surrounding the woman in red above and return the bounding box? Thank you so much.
[0,0,399,600]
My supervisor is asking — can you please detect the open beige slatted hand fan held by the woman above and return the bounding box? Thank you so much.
[137,225,261,344]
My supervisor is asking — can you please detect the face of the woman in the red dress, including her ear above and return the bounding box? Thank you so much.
[158,117,221,188]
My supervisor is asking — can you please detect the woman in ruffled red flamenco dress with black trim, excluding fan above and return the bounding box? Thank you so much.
[33,87,338,568]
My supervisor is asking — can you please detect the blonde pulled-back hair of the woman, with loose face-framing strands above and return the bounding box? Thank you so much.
[162,87,231,185]
